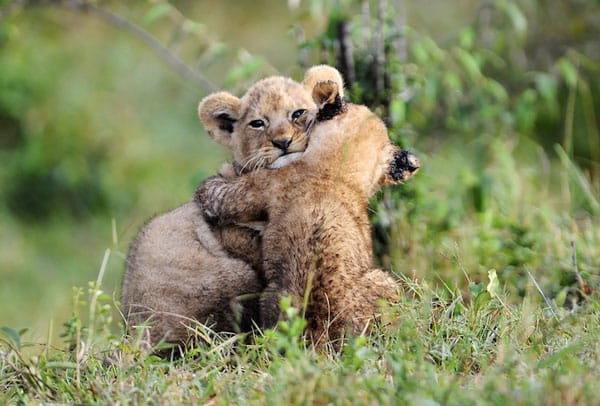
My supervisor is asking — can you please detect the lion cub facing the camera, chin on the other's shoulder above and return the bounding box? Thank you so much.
[122,66,341,345]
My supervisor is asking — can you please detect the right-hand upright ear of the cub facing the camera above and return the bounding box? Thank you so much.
[302,65,344,110]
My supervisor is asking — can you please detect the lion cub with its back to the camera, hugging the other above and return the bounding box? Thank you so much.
[196,71,419,344]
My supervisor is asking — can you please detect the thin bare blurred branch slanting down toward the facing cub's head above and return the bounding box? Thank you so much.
[63,0,218,92]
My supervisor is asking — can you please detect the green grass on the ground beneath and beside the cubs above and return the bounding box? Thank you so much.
[0,146,600,405]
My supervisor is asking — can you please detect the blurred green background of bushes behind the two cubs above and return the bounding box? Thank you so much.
[0,0,600,340]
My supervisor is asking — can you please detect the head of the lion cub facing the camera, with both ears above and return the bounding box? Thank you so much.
[198,65,343,173]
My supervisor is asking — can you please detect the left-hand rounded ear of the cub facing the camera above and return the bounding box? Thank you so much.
[198,92,242,147]
